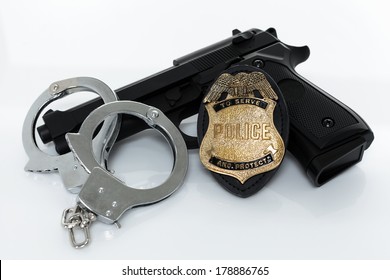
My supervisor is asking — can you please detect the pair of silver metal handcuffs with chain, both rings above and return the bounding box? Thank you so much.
[23,77,188,248]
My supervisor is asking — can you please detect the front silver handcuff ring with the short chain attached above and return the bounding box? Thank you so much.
[62,101,188,248]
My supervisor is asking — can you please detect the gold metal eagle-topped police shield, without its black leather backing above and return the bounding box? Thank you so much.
[200,72,285,184]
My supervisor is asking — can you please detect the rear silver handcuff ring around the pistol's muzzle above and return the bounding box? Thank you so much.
[22,77,120,193]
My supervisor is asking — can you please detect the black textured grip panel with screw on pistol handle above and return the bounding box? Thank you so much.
[264,61,358,138]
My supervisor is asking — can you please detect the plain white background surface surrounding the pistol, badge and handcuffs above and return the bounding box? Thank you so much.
[0,0,390,259]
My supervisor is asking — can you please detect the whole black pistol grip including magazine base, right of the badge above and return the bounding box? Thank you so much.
[264,61,374,186]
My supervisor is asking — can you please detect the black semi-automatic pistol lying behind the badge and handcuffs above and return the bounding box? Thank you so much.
[37,28,374,186]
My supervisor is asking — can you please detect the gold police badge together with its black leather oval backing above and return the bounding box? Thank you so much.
[198,67,289,197]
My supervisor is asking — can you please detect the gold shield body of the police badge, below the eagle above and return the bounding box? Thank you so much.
[200,97,284,184]
